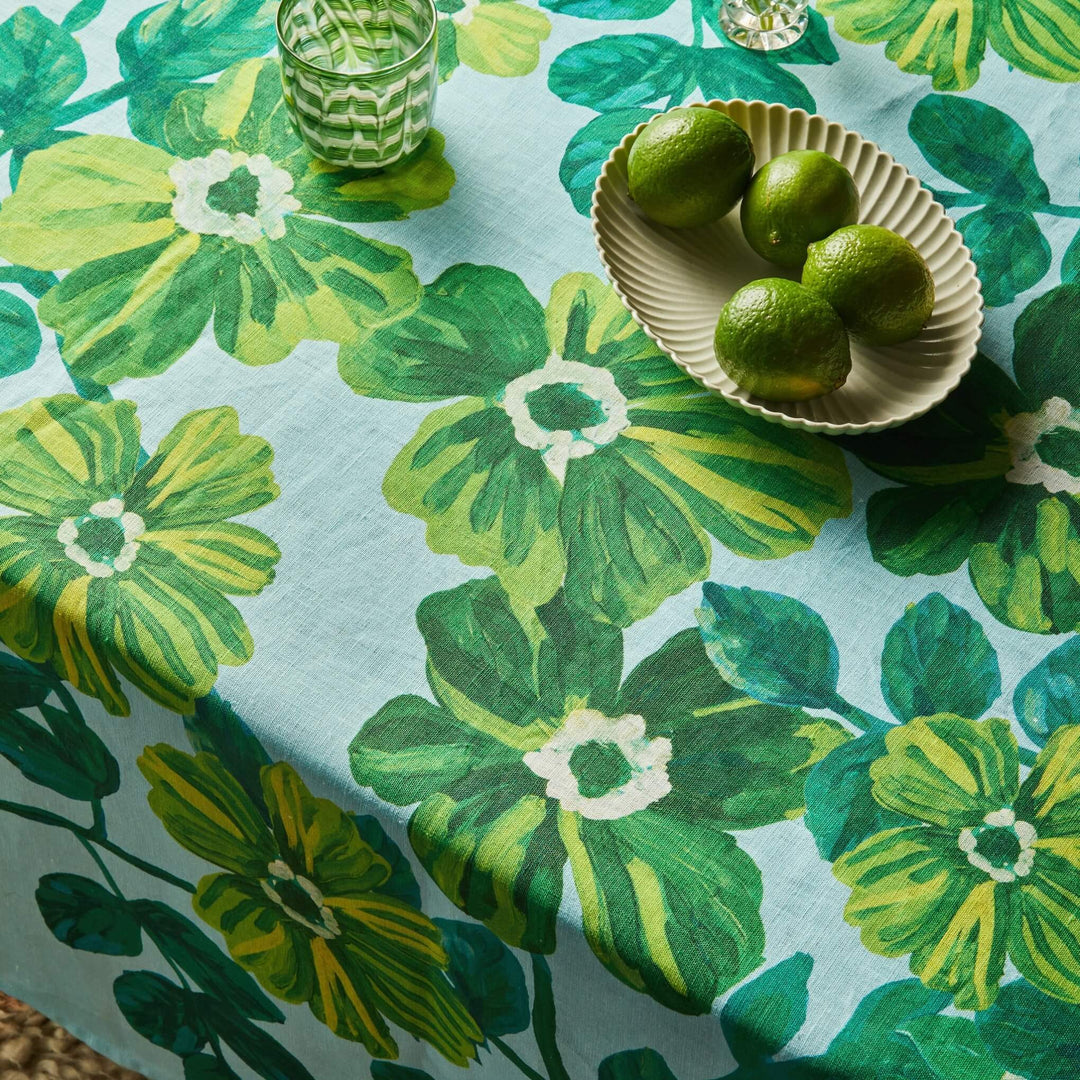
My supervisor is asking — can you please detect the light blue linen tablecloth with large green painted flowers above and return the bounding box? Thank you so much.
[0,0,1080,1080]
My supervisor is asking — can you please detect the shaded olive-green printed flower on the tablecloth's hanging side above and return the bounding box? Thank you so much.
[138,743,483,1065]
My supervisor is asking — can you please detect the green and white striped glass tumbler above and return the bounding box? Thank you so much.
[278,0,438,168]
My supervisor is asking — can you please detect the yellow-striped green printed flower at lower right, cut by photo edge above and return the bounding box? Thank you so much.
[833,713,1080,1009]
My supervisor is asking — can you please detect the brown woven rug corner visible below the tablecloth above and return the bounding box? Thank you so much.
[0,993,145,1080]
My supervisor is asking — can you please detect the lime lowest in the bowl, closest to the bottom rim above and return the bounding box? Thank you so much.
[715,278,851,402]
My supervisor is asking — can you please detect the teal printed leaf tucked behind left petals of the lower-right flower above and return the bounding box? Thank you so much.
[802,732,907,863]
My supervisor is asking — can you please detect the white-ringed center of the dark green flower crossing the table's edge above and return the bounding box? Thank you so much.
[523,708,672,821]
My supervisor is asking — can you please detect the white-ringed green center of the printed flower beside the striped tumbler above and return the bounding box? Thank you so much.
[168,149,300,244]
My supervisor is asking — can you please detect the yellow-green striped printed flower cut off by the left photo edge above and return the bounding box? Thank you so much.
[0,394,281,715]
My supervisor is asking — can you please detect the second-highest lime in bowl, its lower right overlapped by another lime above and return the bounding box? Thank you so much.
[740,150,859,270]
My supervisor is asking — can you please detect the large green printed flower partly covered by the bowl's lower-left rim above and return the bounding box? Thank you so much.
[339,265,851,625]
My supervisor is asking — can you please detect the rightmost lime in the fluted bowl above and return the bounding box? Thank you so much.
[802,225,934,345]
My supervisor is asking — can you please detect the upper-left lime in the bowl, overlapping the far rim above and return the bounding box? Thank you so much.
[626,106,754,229]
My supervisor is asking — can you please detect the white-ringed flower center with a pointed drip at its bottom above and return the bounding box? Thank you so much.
[501,356,630,484]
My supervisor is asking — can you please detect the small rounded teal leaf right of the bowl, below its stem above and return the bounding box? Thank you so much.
[956,204,1051,308]
